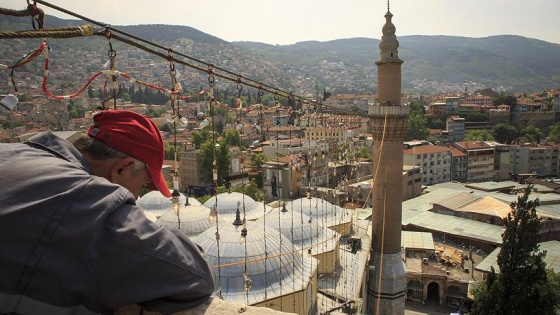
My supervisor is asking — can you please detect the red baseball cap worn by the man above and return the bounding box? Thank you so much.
[87,110,171,198]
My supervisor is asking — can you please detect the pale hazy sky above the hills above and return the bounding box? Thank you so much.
[0,0,560,45]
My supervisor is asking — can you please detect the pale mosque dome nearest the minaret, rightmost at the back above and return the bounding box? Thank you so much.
[286,197,353,227]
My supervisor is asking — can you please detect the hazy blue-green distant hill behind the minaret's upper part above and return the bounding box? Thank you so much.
[236,35,560,90]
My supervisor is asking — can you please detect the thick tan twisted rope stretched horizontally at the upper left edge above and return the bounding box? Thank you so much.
[0,25,98,38]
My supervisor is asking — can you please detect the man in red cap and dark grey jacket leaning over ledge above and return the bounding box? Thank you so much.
[0,110,214,315]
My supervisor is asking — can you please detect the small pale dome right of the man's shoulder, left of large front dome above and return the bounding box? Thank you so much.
[156,205,216,237]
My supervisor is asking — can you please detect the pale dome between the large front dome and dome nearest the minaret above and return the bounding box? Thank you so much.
[257,208,339,255]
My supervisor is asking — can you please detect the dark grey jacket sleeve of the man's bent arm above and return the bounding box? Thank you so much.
[97,204,214,314]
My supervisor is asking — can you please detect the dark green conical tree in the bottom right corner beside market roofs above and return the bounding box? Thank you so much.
[471,185,560,315]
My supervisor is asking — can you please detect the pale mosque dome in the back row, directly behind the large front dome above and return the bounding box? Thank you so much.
[204,192,272,222]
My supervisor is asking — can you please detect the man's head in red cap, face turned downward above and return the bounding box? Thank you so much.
[77,110,171,197]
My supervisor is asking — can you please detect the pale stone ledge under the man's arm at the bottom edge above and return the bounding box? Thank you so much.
[115,298,293,315]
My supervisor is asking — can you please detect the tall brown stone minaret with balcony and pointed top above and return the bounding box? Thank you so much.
[367,1,410,315]
